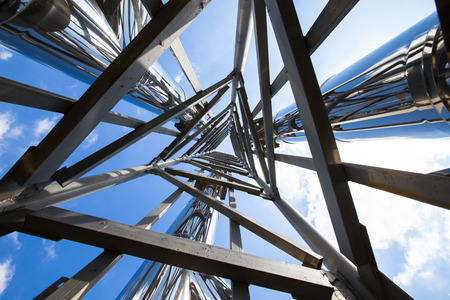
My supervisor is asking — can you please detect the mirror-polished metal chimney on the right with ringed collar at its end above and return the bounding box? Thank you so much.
[274,14,450,139]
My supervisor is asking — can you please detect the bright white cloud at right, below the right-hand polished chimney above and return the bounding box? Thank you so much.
[277,138,450,289]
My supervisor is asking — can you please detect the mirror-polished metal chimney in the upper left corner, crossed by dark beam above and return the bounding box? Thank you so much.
[0,0,196,122]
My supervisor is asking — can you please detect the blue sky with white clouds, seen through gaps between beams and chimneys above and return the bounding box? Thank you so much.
[0,0,450,299]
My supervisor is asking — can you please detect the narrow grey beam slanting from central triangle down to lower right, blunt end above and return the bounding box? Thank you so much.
[154,169,322,269]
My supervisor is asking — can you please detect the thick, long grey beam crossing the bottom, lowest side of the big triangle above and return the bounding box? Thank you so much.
[23,207,333,299]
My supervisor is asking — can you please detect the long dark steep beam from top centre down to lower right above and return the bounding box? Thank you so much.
[266,0,388,297]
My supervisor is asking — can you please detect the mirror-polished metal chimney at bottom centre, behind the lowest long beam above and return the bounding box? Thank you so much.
[117,175,231,299]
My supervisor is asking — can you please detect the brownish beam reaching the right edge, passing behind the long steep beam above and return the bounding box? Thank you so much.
[275,154,450,209]
